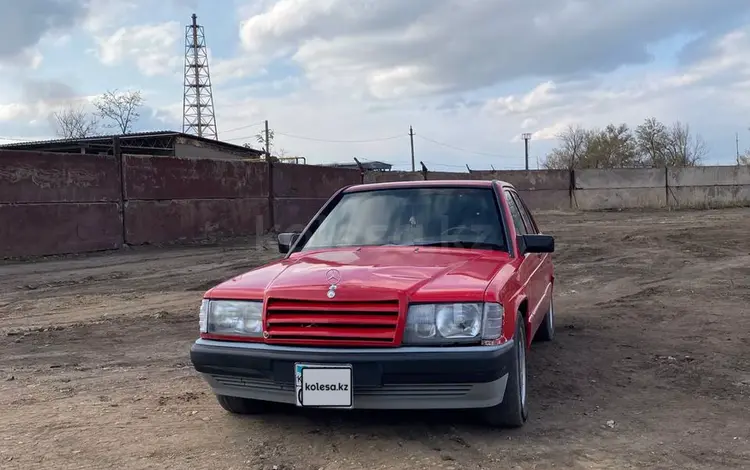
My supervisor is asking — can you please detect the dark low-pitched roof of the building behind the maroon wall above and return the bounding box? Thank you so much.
[0,131,263,156]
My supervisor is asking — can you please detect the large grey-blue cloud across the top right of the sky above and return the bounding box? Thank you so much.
[240,0,750,99]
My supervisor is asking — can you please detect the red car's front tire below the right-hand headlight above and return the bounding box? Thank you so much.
[481,314,529,428]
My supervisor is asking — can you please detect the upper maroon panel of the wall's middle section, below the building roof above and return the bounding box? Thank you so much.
[125,155,268,200]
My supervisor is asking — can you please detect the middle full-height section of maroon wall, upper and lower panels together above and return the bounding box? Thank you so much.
[125,155,270,245]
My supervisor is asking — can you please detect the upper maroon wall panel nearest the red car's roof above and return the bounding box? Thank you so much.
[273,163,362,198]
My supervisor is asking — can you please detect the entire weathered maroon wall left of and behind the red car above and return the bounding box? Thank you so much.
[0,151,361,258]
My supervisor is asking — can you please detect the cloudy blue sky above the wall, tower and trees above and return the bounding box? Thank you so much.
[0,0,750,171]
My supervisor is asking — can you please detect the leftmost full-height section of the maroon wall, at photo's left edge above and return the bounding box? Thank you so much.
[0,151,122,257]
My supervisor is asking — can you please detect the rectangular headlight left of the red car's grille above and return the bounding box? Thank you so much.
[200,299,263,337]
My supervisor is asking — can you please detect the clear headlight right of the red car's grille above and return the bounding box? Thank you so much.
[403,302,503,344]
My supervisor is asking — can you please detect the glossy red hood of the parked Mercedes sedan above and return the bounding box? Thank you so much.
[207,246,510,301]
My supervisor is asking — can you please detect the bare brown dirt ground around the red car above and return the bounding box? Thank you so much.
[0,209,750,470]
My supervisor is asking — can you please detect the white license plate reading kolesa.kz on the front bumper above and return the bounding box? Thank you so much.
[294,363,354,408]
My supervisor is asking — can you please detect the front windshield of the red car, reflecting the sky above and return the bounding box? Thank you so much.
[303,187,507,251]
